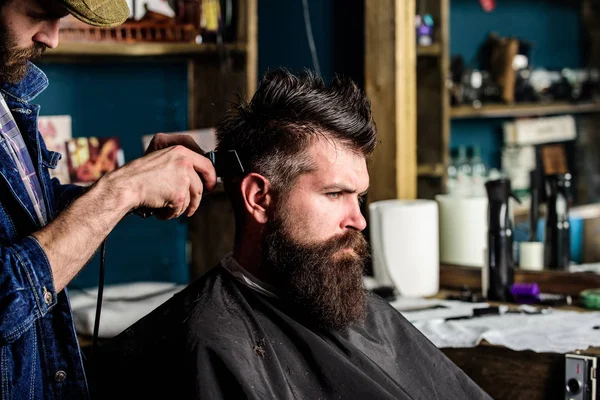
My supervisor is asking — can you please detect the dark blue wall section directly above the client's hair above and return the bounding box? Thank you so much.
[258,0,364,85]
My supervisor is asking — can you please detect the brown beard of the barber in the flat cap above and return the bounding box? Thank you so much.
[0,24,46,83]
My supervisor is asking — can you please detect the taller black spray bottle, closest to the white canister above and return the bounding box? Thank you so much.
[483,178,519,301]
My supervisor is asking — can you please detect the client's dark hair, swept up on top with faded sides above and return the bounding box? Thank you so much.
[216,68,377,198]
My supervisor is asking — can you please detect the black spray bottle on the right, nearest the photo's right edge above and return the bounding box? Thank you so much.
[544,173,571,270]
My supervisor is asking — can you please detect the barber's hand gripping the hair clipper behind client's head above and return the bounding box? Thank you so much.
[106,145,217,219]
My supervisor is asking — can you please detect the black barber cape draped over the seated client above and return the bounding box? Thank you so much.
[88,266,489,400]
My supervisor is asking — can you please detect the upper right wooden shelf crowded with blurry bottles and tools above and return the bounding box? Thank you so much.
[448,33,600,119]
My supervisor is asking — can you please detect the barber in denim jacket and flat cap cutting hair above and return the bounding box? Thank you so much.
[0,0,216,399]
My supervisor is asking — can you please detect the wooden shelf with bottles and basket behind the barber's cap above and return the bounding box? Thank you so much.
[42,0,248,61]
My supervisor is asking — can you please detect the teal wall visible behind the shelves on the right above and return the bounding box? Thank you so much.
[450,0,585,168]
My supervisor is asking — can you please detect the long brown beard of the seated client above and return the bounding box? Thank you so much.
[262,211,369,330]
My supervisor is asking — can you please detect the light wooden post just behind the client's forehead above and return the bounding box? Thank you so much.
[365,0,417,202]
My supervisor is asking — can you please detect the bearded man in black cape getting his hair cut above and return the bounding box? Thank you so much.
[92,70,489,399]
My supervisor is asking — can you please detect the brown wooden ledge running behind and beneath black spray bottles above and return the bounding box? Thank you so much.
[440,265,600,296]
